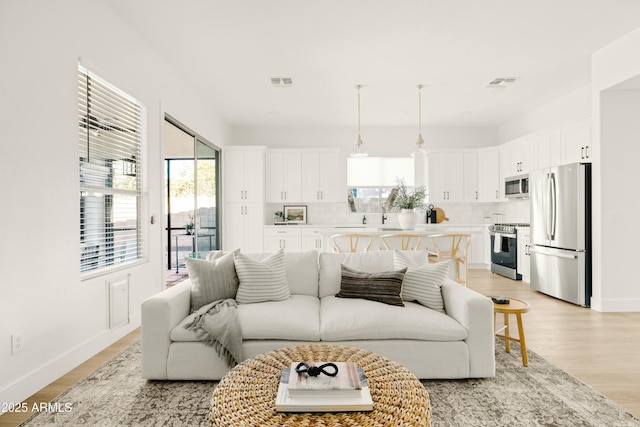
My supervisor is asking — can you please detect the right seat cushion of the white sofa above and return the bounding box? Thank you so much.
[320,296,467,341]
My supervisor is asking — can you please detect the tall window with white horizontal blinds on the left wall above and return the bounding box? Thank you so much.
[78,67,144,274]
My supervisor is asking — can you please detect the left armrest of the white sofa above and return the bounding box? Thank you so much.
[140,280,191,380]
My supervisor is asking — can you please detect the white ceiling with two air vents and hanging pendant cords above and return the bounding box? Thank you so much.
[106,0,640,127]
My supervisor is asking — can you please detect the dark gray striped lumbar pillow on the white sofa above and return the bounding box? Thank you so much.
[336,264,407,307]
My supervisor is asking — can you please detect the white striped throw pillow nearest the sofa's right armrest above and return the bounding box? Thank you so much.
[393,250,449,313]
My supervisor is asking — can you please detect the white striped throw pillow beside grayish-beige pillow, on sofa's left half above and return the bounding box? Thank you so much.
[234,249,291,304]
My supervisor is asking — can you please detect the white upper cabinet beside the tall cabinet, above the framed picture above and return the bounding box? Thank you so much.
[265,150,302,203]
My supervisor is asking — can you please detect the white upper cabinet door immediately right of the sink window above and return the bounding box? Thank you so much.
[429,152,464,203]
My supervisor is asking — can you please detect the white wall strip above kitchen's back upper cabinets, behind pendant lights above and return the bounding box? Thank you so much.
[231,126,498,156]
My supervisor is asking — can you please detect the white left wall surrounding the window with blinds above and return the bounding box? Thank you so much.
[0,0,229,408]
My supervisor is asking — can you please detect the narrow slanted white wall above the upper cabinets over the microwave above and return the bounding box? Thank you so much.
[497,85,591,143]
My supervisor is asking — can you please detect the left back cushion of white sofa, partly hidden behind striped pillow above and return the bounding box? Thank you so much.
[240,250,318,297]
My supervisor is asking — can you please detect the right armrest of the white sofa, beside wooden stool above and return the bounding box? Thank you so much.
[442,279,496,378]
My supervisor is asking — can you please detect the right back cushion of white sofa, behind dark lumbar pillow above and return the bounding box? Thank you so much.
[318,251,394,298]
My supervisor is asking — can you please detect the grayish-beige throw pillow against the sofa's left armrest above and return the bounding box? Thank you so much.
[185,252,239,312]
